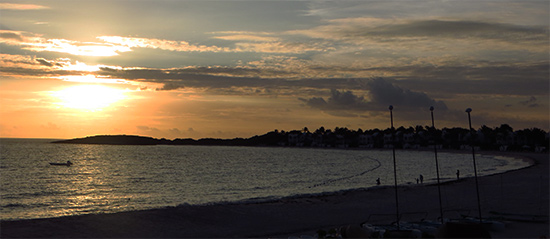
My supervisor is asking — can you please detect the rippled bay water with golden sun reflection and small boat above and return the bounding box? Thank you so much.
[0,139,528,220]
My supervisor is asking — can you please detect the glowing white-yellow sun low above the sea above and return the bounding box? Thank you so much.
[53,85,125,111]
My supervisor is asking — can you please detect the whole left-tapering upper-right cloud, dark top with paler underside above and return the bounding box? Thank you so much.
[292,17,550,56]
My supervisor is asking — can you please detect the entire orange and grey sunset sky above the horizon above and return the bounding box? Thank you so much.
[0,0,550,139]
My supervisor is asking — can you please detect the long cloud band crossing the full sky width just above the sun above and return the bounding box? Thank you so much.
[0,50,550,98]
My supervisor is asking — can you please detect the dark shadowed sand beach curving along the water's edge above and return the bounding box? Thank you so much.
[0,152,550,238]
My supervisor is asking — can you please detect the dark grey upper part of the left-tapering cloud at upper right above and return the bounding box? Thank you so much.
[316,20,550,45]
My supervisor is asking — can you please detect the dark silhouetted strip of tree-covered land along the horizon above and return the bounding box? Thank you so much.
[53,124,549,152]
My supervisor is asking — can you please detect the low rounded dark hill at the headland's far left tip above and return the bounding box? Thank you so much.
[52,135,162,145]
